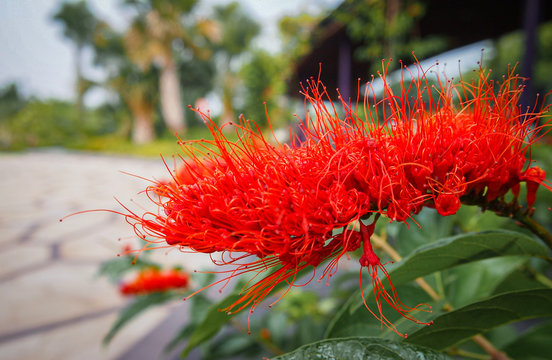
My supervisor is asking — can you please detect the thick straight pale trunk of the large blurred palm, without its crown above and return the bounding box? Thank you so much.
[159,59,186,135]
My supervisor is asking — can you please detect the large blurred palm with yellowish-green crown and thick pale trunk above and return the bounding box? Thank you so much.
[125,0,216,134]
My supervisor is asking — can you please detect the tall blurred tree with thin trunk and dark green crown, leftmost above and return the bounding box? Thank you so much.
[53,0,98,114]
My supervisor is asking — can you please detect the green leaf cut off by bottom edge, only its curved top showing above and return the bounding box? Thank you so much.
[275,337,450,360]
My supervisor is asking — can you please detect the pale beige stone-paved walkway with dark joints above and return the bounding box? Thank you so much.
[0,150,209,360]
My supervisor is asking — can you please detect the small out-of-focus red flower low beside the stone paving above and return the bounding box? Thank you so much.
[119,268,190,295]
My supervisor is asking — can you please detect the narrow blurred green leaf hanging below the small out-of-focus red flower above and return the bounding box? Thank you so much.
[103,292,182,345]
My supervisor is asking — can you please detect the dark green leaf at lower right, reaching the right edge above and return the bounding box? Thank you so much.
[406,289,552,350]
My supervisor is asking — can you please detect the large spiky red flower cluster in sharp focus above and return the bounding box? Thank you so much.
[118,62,550,338]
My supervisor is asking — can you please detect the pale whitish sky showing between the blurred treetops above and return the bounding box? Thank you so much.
[0,0,340,102]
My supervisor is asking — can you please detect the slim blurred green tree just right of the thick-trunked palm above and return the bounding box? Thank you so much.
[214,2,260,123]
